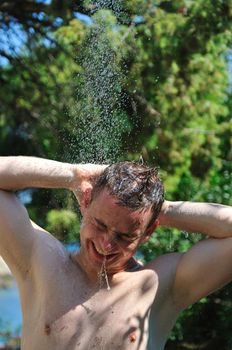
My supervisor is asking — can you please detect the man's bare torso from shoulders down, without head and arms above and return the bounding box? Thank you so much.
[20,237,181,350]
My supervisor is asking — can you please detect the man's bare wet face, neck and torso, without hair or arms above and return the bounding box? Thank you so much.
[20,192,178,350]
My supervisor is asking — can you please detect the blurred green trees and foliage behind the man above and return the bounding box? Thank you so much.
[0,0,232,349]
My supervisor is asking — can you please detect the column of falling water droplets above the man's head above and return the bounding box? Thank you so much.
[65,5,129,163]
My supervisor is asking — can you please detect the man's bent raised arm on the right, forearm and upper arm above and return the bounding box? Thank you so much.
[160,202,232,308]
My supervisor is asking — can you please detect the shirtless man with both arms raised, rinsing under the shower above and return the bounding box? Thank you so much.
[0,157,232,350]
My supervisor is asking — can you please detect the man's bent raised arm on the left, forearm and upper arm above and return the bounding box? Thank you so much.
[0,156,105,276]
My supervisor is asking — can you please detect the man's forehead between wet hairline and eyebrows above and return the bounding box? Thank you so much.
[89,189,151,230]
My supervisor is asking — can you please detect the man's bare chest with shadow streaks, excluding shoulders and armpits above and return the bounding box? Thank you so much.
[21,266,157,350]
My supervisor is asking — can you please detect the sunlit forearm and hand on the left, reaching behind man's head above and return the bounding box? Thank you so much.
[0,156,106,200]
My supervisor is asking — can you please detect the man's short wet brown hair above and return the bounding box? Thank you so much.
[92,161,164,224]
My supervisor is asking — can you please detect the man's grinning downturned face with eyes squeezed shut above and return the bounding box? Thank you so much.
[80,190,151,273]
